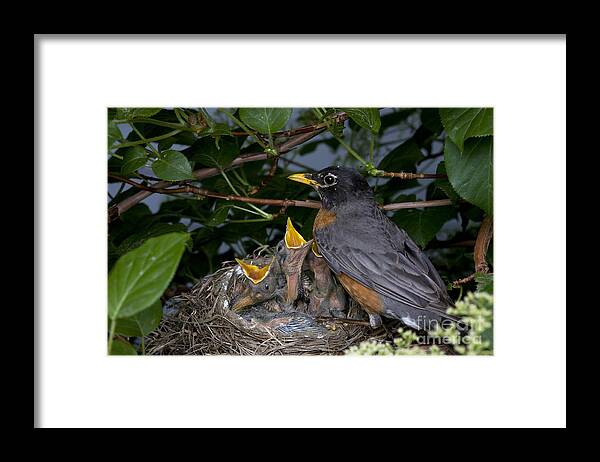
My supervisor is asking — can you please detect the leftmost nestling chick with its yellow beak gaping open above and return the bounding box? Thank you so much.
[229,257,283,311]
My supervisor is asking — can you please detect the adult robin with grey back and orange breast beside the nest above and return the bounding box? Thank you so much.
[288,166,463,330]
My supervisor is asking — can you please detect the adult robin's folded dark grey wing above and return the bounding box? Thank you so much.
[315,207,451,313]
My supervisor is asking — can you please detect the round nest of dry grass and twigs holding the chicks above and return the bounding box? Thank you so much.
[145,265,388,355]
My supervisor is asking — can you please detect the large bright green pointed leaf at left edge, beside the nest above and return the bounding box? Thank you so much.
[108,233,189,319]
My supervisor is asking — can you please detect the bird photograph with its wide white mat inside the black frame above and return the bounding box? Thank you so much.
[34,35,566,428]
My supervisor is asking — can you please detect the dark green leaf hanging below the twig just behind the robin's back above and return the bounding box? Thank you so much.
[393,207,456,248]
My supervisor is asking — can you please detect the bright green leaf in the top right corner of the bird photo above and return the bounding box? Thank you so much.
[440,108,494,152]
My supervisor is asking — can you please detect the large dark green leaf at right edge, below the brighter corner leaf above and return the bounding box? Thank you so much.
[444,136,493,215]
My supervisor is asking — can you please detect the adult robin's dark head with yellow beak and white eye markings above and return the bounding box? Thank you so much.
[288,166,373,209]
